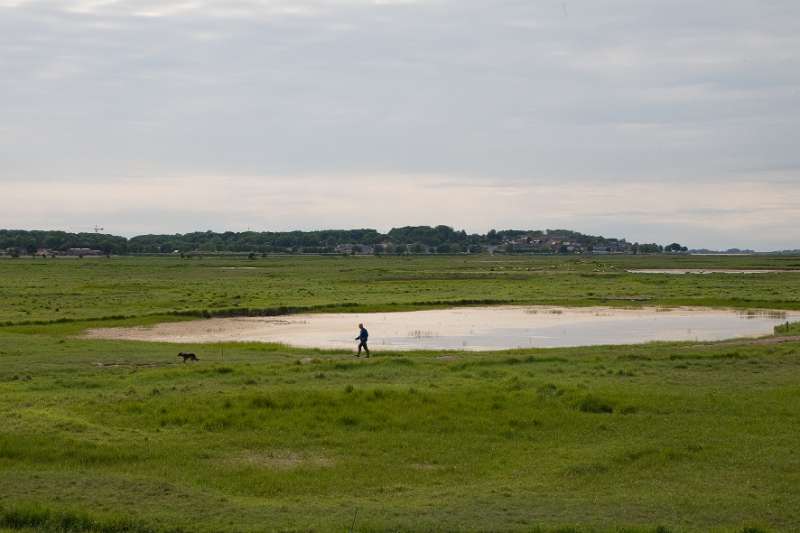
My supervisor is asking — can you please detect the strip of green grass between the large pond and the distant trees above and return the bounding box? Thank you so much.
[0,256,800,324]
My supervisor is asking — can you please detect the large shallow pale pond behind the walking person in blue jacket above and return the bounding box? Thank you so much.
[88,306,800,351]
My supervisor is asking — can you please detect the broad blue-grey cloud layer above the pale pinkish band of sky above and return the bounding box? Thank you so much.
[0,0,800,247]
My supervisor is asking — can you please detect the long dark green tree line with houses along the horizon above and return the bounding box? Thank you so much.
[0,226,686,255]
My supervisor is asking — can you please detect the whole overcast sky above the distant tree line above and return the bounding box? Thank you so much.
[0,0,800,251]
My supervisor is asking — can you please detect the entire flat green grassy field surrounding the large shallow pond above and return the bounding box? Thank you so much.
[0,256,800,532]
